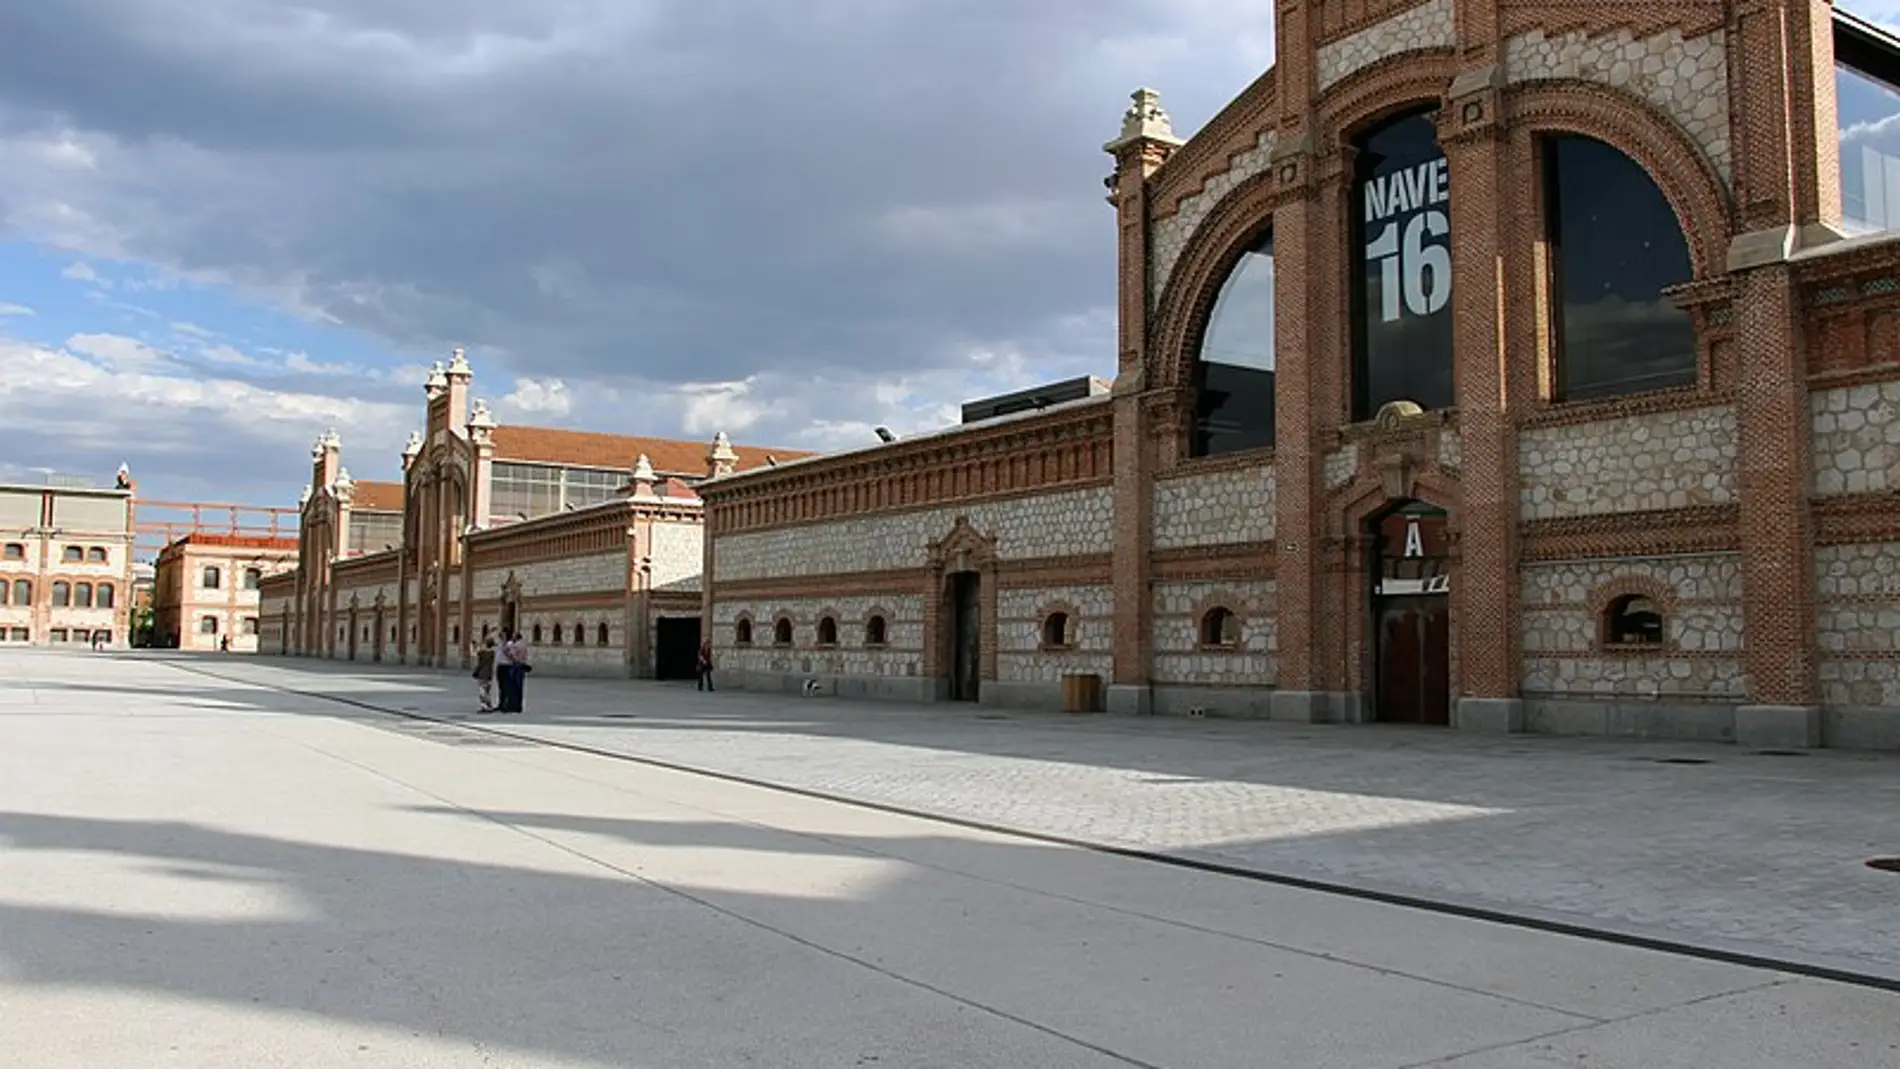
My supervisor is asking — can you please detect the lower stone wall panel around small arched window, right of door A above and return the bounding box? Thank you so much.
[1520,553,1746,725]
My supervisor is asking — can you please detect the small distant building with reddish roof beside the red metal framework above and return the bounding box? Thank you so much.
[152,532,298,653]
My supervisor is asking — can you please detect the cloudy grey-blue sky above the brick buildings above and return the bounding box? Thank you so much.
[0,0,1887,520]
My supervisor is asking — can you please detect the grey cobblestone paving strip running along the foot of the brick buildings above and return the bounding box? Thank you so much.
[178,661,1900,976]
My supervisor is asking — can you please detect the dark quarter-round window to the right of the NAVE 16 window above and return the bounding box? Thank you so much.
[1543,135,1697,401]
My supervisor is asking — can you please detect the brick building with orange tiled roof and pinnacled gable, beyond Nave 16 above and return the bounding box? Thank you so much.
[258,349,806,678]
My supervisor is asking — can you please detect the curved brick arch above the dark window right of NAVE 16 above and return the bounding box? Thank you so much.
[1505,78,1733,279]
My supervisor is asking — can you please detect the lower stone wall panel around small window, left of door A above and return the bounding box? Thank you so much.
[1150,579,1275,691]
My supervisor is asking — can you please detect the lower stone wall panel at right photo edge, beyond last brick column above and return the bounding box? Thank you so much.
[1815,543,1900,748]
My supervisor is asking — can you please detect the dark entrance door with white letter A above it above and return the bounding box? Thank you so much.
[1372,501,1452,725]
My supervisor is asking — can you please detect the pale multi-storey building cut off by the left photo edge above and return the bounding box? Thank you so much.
[0,467,133,649]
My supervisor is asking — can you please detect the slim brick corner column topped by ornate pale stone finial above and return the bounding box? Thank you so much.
[1102,89,1182,714]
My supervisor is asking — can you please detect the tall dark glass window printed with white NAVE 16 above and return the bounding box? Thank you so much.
[1351,112,1455,420]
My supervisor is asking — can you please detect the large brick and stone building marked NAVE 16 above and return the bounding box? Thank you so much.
[699,0,1900,748]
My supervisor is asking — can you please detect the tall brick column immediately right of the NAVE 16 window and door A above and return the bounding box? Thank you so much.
[1438,65,1530,731]
